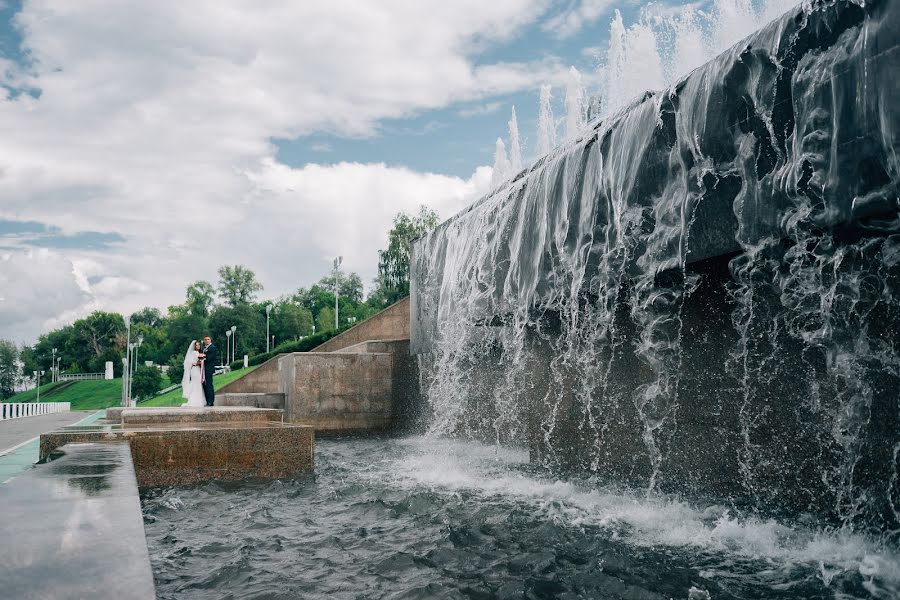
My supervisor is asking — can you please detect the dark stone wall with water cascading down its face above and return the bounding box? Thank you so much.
[411,0,900,531]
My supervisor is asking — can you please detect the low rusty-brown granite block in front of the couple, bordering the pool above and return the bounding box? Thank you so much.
[40,422,315,488]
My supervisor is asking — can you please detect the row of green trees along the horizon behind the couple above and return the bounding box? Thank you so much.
[0,207,438,400]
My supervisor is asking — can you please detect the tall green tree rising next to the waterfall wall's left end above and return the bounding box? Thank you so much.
[372,206,438,307]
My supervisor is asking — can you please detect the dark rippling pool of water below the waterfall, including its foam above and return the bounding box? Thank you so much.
[142,438,900,600]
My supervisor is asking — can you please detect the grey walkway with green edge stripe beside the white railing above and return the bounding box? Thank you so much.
[0,410,103,484]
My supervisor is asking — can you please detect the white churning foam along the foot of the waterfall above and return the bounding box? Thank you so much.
[378,438,900,597]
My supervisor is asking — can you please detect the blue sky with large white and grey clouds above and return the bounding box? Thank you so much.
[0,0,792,343]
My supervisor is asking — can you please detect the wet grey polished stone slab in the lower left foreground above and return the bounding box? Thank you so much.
[0,443,156,600]
